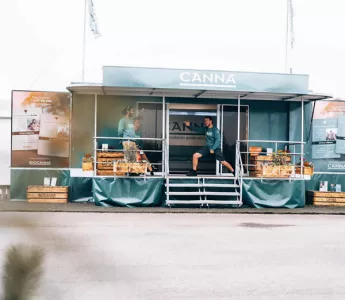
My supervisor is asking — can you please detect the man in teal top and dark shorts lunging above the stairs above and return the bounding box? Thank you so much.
[184,117,234,176]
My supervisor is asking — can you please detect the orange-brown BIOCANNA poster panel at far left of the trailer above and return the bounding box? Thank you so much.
[11,91,70,168]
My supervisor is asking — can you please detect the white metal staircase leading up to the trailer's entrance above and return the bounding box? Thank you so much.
[165,175,242,207]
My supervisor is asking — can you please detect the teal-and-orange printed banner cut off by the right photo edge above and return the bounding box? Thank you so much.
[312,101,345,172]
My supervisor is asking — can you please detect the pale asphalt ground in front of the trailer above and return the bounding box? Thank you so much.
[0,212,345,300]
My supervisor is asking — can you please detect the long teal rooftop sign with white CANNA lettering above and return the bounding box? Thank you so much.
[103,67,309,94]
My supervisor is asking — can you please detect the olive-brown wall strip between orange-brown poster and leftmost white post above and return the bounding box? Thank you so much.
[71,94,95,168]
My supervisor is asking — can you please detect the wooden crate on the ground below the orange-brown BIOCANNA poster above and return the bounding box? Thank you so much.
[27,185,68,203]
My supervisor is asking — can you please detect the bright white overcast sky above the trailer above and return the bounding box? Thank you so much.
[0,0,345,100]
